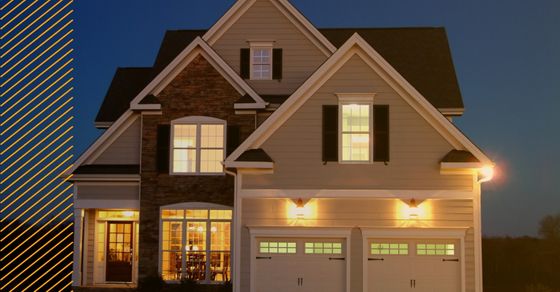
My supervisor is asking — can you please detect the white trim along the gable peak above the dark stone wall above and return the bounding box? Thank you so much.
[130,37,267,110]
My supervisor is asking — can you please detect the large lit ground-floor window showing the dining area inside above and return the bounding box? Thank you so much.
[160,208,232,282]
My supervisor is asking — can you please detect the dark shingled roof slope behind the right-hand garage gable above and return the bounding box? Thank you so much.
[320,27,464,110]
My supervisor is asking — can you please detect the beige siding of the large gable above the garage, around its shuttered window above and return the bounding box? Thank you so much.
[243,55,472,190]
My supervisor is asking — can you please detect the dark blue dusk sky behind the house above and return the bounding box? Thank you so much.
[74,0,560,236]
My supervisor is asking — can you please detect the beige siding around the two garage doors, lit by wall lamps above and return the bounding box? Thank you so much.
[241,198,475,292]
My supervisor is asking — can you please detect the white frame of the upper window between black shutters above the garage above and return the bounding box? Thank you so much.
[336,93,375,164]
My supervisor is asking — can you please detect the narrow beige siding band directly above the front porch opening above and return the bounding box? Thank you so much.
[77,183,140,200]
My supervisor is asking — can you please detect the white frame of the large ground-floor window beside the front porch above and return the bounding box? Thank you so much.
[158,202,233,284]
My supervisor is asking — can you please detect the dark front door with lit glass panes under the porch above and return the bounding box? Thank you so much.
[105,221,133,282]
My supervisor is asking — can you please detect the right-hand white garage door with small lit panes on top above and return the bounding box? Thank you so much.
[367,239,461,292]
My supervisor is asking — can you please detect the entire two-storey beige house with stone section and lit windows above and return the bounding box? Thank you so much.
[67,0,493,292]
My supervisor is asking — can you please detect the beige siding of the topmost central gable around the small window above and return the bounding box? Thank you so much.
[213,0,327,94]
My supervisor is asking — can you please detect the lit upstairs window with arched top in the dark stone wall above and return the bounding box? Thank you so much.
[171,117,225,174]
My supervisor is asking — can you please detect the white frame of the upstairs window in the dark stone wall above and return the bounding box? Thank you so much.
[169,116,227,175]
